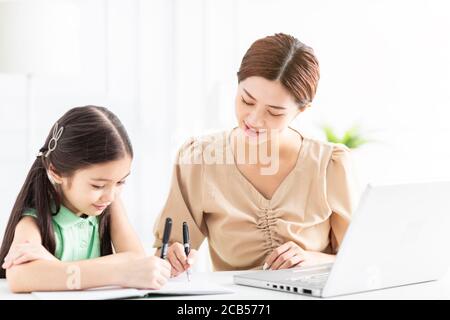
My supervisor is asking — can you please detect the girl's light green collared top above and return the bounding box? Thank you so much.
[23,205,100,261]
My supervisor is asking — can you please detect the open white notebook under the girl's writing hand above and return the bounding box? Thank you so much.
[32,277,234,300]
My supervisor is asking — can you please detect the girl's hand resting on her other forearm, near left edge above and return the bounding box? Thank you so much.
[2,241,58,269]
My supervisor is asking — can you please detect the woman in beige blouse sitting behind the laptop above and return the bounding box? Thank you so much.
[154,34,354,276]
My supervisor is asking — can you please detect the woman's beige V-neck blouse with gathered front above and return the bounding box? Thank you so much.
[154,132,356,271]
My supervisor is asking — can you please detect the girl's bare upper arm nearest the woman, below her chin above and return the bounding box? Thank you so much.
[110,197,145,255]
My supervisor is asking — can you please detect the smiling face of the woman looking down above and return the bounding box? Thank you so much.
[236,77,302,140]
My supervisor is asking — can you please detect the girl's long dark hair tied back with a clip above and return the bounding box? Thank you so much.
[0,106,133,278]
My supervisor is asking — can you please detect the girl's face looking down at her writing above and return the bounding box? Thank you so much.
[50,156,131,216]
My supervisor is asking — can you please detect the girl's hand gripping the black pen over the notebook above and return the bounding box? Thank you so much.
[119,256,171,290]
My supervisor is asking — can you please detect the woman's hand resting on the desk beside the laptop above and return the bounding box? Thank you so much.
[263,241,336,270]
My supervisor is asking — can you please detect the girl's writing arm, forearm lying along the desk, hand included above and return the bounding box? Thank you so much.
[6,217,170,292]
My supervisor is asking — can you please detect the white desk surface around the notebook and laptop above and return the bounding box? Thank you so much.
[0,271,450,300]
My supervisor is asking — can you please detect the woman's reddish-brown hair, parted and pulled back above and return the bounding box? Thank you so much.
[237,33,320,107]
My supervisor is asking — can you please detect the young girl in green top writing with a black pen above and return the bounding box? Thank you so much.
[0,106,171,292]
